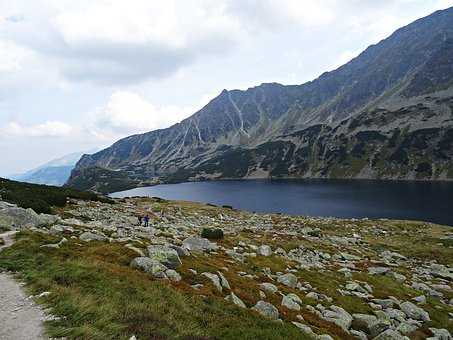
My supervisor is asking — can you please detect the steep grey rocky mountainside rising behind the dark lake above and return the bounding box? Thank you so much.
[68,8,453,191]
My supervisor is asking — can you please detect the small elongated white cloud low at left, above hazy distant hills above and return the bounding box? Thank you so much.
[0,121,73,137]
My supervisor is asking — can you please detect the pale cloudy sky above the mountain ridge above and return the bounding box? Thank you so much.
[0,0,453,176]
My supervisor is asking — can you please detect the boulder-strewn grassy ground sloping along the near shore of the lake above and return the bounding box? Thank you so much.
[0,198,453,340]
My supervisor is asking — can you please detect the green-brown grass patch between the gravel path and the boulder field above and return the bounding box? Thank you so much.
[0,232,304,339]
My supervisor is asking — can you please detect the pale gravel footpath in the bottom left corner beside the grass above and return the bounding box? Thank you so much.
[0,232,47,340]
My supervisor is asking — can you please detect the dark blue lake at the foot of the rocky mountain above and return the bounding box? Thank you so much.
[111,180,453,226]
